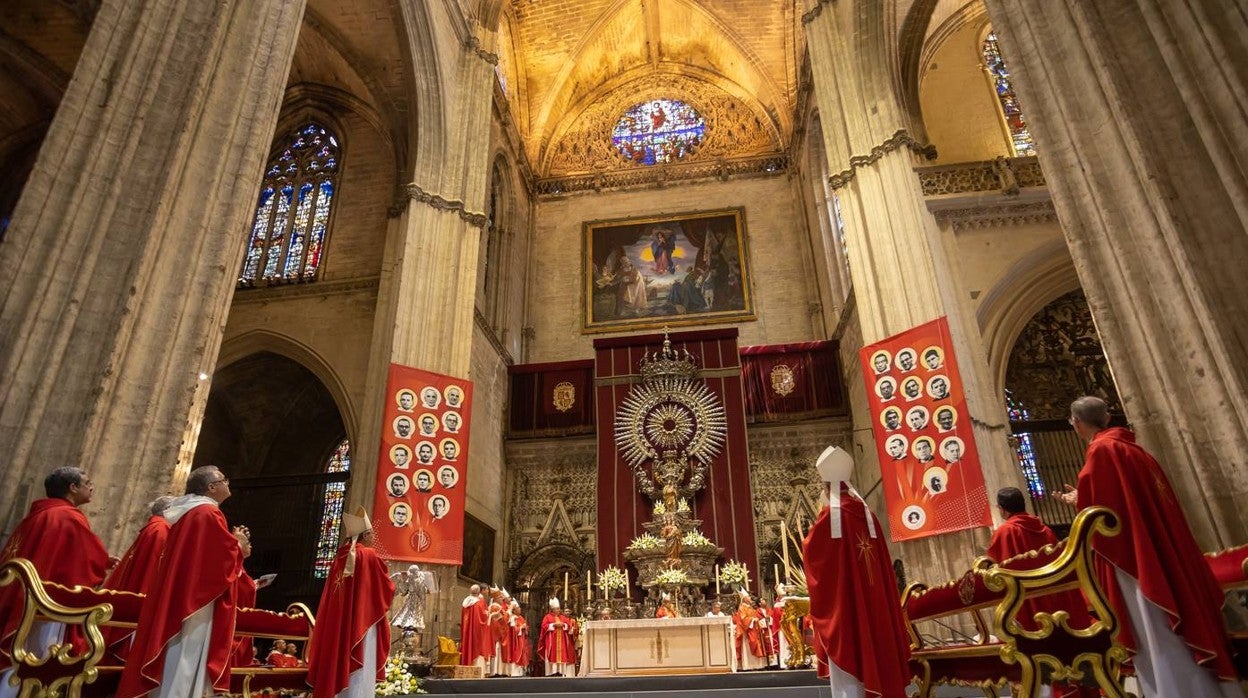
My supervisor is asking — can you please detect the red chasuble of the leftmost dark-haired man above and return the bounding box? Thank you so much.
[0,497,109,669]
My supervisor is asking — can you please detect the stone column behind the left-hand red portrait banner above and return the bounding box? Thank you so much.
[348,31,502,638]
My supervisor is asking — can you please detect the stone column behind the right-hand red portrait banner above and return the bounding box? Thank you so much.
[802,1,1022,582]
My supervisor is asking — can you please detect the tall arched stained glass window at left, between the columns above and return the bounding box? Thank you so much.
[238,122,341,287]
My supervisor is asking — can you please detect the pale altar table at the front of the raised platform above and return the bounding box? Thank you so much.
[579,616,736,677]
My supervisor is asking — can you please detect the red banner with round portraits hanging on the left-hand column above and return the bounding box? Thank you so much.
[373,363,472,564]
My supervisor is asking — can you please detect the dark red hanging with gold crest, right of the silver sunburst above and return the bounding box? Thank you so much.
[741,340,846,422]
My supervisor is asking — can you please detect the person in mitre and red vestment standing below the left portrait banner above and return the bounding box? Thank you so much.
[308,507,394,698]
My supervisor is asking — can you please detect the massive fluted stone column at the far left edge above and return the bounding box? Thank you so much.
[0,0,305,552]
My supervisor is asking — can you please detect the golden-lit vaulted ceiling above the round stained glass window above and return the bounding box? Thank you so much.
[500,0,804,174]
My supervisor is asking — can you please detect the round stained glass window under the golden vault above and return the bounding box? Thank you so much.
[612,100,706,165]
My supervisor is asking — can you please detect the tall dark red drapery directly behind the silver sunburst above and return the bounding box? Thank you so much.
[594,327,758,573]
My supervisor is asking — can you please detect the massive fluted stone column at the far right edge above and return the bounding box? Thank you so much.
[986,0,1248,548]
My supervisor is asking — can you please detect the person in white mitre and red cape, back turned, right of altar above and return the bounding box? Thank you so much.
[801,446,910,698]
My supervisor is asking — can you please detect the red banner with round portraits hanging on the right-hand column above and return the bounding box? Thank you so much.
[860,317,992,541]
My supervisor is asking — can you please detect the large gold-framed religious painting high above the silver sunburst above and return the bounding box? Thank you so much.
[584,209,755,333]
